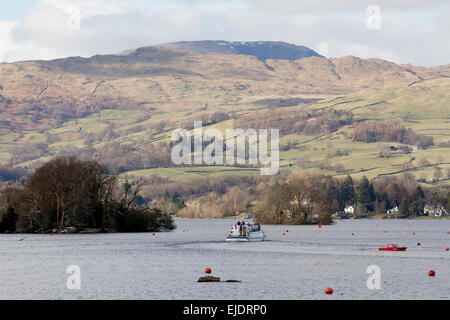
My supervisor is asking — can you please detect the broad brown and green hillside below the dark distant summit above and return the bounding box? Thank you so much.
[0,43,450,188]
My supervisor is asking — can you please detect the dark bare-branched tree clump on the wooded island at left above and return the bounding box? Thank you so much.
[0,157,174,233]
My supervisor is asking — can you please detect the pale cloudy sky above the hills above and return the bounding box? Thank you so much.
[0,0,450,66]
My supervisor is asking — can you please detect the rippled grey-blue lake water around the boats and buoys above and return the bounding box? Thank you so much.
[0,219,450,300]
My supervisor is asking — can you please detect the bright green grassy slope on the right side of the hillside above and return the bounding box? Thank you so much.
[282,79,450,178]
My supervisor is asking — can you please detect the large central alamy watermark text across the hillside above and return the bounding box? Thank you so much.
[171,121,280,175]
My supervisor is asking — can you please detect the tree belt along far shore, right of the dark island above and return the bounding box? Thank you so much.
[143,171,450,224]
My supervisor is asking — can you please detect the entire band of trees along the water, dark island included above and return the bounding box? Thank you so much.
[0,157,450,226]
